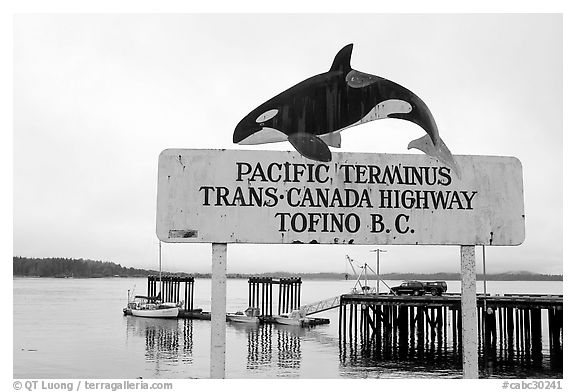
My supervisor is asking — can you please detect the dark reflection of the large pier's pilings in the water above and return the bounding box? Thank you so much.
[339,308,563,378]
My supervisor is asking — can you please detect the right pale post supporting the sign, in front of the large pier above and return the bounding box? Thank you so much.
[460,245,478,378]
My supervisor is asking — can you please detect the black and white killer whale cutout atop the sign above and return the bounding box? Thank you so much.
[234,44,459,177]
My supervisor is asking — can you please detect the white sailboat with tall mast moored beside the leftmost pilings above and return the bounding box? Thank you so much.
[124,242,182,318]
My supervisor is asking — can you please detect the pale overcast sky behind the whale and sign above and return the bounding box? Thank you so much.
[13,14,563,274]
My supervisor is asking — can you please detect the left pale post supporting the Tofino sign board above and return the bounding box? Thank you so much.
[210,243,226,378]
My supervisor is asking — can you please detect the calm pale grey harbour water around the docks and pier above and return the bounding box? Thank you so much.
[13,278,562,379]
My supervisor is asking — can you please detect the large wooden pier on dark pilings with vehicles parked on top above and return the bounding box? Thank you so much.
[339,294,563,361]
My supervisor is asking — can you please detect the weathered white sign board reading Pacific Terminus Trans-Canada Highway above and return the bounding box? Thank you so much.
[156,149,524,245]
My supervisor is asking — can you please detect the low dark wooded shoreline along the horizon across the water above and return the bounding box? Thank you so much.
[12,256,563,281]
